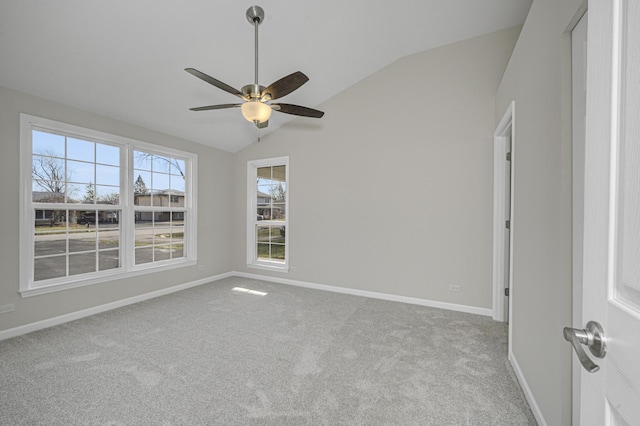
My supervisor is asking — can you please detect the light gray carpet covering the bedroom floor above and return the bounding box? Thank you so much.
[0,278,536,425]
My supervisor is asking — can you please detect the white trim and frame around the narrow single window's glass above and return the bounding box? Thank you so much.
[246,157,291,272]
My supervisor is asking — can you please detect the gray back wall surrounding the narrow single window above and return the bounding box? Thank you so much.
[233,27,520,308]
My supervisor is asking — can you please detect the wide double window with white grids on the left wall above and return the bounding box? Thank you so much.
[20,114,196,295]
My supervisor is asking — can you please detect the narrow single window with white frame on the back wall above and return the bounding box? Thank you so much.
[247,157,289,271]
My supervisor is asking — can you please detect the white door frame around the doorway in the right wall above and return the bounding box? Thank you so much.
[493,101,516,330]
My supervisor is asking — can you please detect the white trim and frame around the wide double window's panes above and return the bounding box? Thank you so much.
[19,113,198,297]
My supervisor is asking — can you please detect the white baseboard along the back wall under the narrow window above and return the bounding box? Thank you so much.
[233,271,493,317]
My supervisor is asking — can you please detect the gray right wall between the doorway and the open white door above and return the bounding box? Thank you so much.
[496,0,581,425]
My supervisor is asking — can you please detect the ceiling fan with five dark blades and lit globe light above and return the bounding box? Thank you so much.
[185,6,324,129]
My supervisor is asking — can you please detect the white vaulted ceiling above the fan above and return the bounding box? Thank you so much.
[0,0,531,152]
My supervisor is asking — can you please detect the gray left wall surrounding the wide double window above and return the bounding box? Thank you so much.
[0,87,232,330]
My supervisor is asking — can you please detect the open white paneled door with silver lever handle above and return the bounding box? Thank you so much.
[578,0,640,425]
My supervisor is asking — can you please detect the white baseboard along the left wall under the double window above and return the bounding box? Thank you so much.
[0,272,234,341]
